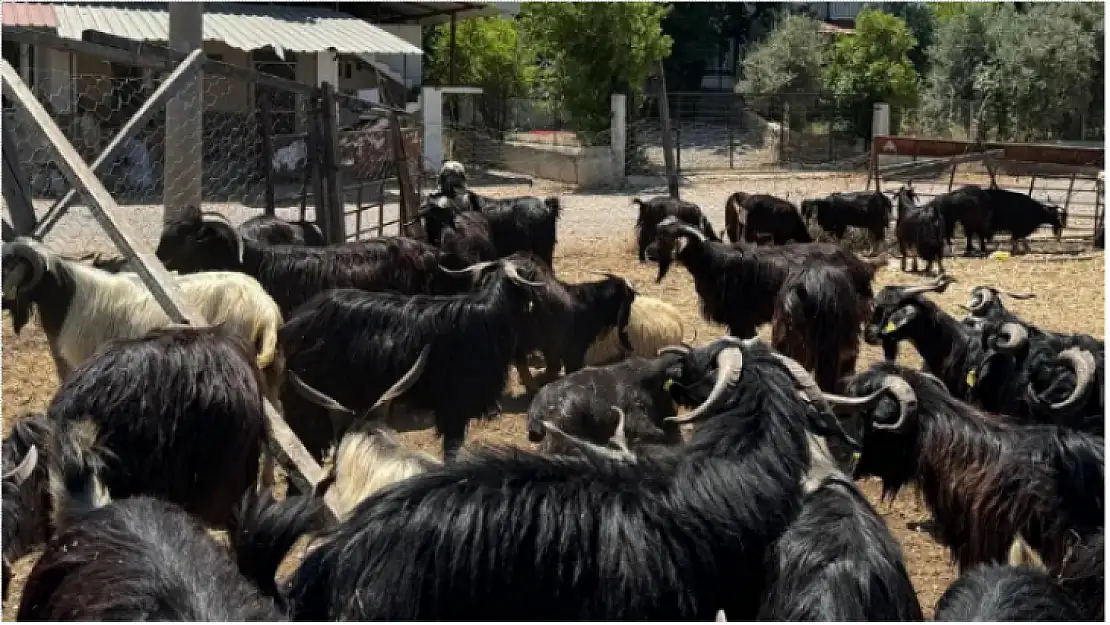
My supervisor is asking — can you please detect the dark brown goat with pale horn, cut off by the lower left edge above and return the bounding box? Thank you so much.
[0,414,50,597]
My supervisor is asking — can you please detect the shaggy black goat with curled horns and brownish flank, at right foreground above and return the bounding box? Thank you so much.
[847,363,1104,574]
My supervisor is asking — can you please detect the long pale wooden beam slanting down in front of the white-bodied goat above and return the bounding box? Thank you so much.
[0,59,323,501]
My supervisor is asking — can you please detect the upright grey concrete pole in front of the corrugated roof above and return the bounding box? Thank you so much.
[162,2,204,221]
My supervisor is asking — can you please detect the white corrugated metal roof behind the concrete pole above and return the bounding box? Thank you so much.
[54,2,423,54]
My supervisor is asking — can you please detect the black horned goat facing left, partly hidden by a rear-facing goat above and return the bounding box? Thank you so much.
[656,218,886,339]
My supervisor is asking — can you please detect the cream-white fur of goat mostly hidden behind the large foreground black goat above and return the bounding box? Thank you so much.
[324,424,442,521]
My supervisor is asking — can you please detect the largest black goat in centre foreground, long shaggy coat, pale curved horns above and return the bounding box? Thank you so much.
[238,337,870,621]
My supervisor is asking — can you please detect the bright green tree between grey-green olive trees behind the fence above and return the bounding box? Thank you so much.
[824,10,918,137]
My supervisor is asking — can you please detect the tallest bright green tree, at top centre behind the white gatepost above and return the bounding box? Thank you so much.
[519,2,672,132]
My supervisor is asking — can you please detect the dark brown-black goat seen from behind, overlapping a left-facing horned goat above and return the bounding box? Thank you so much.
[771,263,870,391]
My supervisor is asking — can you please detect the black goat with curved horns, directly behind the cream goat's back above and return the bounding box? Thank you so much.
[155,206,457,317]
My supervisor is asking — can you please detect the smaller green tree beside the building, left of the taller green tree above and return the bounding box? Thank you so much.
[424,18,536,130]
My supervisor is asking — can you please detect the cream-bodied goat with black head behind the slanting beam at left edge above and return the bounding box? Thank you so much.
[3,238,283,401]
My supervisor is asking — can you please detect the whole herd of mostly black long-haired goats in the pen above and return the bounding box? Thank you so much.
[2,162,1103,621]
